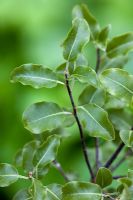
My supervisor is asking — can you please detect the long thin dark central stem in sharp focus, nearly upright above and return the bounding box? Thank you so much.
[65,70,95,182]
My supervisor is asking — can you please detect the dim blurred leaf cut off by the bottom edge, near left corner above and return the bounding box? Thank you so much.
[13,189,33,200]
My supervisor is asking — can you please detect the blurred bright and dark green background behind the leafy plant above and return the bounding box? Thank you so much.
[0,0,133,200]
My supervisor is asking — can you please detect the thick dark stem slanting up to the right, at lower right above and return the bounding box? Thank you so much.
[104,142,125,168]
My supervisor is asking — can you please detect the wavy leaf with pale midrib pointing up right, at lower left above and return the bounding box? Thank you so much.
[33,135,60,171]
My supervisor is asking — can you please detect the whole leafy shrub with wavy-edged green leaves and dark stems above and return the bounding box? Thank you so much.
[0,5,133,200]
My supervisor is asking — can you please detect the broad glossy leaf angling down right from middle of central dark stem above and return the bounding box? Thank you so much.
[78,104,115,140]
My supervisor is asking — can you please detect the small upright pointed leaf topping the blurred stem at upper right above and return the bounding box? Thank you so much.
[96,24,111,51]
